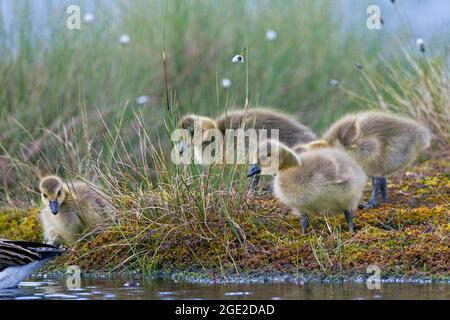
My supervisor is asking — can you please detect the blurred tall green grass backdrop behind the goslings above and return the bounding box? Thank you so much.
[0,0,449,198]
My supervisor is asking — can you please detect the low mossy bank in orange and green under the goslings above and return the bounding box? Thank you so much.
[0,162,450,277]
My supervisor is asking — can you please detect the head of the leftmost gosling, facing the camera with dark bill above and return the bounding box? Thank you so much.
[39,176,66,215]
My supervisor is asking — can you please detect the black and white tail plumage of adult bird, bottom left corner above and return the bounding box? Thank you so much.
[0,239,64,289]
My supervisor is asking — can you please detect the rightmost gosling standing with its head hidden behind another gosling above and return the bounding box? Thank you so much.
[320,112,431,209]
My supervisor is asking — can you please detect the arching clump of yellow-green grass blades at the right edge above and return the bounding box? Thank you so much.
[344,40,450,151]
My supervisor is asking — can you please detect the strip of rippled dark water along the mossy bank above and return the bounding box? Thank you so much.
[0,278,450,300]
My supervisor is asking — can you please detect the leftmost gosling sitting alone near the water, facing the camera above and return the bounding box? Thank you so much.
[39,176,113,244]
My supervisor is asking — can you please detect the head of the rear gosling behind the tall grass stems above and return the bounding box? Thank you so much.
[178,114,217,156]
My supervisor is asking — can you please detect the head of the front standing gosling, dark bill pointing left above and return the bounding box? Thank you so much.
[247,140,301,177]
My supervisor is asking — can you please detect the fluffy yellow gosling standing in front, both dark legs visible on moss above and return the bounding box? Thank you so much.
[247,140,367,234]
